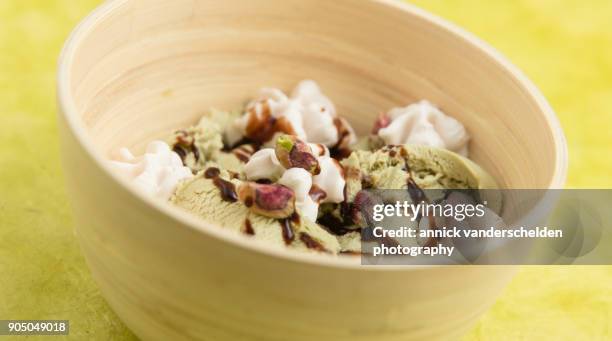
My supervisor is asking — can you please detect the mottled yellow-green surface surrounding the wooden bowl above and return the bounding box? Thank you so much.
[0,0,612,340]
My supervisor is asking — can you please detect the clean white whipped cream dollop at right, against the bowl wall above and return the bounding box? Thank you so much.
[378,100,469,157]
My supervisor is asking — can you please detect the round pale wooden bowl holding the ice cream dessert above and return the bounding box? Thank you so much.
[58,0,567,341]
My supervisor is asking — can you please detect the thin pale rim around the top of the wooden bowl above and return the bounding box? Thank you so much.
[56,0,568,271]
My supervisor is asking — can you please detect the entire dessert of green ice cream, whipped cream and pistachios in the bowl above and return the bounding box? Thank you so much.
[112,81,496,254]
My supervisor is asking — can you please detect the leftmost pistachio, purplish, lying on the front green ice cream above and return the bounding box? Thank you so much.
[238,182,295,219]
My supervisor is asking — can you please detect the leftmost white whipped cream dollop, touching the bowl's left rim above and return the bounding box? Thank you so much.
[110,141,193,200]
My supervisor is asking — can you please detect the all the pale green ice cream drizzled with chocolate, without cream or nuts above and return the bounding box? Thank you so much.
[170,111,497,254]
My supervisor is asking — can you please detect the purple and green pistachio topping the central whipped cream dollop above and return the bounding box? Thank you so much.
[274,135,321,175]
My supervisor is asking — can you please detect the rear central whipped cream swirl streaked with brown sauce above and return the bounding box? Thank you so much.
[225,80,356,147]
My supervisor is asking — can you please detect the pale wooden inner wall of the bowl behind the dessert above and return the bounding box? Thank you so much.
[65,0,565,188]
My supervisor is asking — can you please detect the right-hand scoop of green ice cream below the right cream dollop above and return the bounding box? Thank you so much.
[334,145,499,252]
